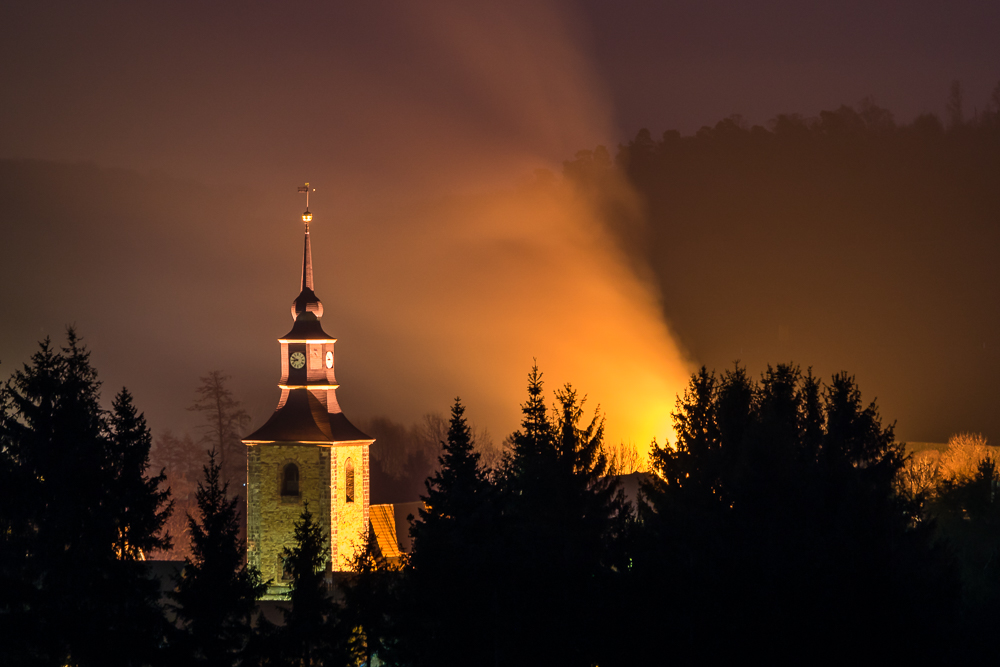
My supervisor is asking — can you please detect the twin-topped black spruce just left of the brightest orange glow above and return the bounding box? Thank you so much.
[496,366,626,665]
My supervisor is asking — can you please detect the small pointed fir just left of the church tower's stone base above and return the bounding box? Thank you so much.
[171,450,264,666]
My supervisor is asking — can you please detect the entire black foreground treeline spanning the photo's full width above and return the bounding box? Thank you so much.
[0,333,1000,665]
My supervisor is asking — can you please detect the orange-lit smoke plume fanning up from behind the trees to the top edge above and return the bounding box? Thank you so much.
[304,2,692,454]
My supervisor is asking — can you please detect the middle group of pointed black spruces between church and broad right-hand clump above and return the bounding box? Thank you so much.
[398,368,626,665]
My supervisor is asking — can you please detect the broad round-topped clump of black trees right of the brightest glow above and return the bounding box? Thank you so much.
[633,365,957,661]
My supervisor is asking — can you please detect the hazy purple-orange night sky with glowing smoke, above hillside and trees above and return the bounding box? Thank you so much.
[0,0,1000,454]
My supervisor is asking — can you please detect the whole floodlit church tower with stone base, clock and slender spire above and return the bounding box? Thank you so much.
[243,183,374,587]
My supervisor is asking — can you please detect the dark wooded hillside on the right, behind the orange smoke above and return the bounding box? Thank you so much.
[564,87,1000,428]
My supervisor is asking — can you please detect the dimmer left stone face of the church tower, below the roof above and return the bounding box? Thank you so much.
[247,444,331,585]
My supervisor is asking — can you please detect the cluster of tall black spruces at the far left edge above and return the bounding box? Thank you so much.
[0,329,170,665]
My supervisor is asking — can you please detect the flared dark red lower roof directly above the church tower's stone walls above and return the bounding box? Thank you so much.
[243,389,372,444]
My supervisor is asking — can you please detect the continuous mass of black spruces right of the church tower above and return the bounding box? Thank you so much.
[398,365,968,665]
